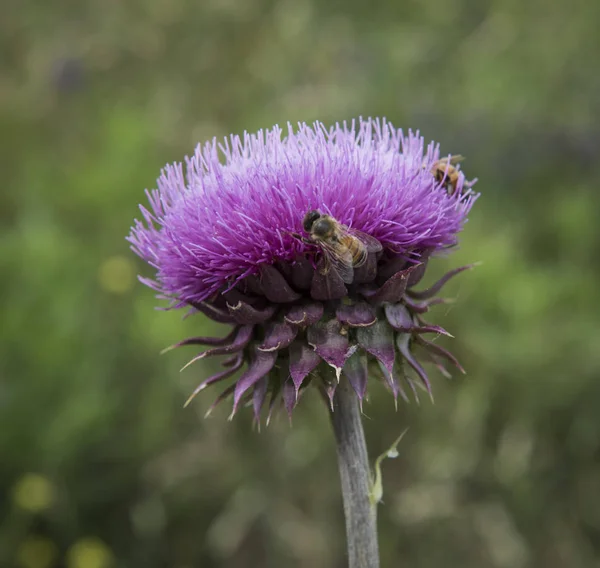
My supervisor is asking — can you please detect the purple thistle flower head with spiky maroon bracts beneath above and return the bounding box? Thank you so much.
[128,119,477,420]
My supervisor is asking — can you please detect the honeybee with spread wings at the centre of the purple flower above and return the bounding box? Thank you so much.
[302,210,383,284]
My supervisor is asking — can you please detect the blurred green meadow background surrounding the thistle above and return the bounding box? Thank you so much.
[0,0,600,568]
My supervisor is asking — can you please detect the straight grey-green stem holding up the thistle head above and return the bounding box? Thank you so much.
[330,380,379,568]
